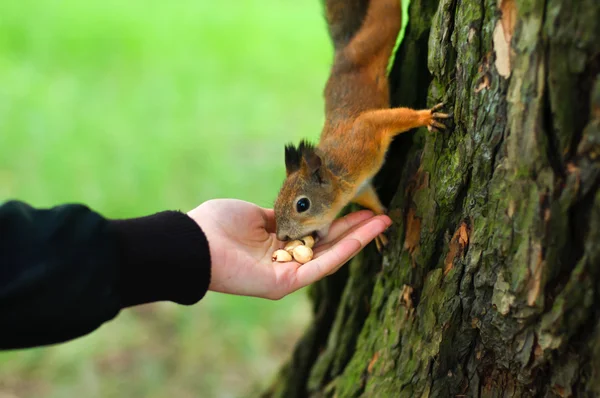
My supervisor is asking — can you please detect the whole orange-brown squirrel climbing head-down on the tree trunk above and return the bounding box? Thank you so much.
[274,0,450,252]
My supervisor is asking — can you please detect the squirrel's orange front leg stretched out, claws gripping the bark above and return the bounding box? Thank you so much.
[358,104,450,140]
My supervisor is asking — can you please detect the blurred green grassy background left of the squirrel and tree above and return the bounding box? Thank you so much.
[0,0,331,398]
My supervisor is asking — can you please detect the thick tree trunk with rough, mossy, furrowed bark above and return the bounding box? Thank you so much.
[264,0,600,398]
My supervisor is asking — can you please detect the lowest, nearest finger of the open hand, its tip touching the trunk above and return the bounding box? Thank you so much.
[292,217,388,291]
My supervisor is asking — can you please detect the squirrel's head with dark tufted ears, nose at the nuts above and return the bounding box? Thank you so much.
[275,141,338,240]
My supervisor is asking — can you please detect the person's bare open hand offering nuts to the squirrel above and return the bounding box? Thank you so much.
[188,199,392,300]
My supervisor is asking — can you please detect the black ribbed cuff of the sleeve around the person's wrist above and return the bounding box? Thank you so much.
[110,211,210,307]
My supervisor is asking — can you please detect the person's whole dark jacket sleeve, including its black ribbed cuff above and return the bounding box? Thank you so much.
[0,201,210,349]
